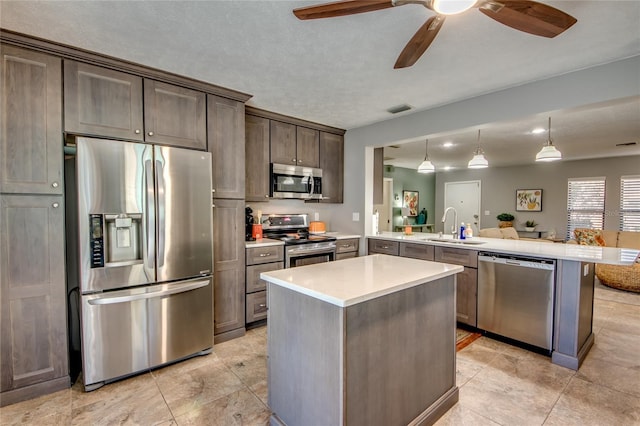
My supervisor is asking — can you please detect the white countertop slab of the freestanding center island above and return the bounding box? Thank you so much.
[260,254,464,307]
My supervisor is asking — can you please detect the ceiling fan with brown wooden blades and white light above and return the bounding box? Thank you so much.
[293,0,577,68]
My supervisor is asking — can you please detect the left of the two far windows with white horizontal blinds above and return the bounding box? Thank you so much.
[567,177,605,239]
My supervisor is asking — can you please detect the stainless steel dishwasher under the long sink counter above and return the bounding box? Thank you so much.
[478,252,555,350]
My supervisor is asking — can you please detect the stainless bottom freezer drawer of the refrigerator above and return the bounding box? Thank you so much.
[82,277,213,390]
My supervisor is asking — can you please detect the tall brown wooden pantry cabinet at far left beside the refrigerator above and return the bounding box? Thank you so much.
[0,45,69,406]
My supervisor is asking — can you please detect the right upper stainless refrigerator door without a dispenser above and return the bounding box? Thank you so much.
[154,146,213,282]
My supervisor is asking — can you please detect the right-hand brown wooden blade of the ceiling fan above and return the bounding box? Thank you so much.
[479,0,578,38]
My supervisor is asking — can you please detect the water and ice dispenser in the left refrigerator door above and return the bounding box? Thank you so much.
[89,213,142,268]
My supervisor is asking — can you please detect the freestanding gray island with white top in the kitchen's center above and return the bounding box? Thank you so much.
[261,254,463,426]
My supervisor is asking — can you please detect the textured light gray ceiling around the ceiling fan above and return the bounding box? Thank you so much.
[0,1,640,166]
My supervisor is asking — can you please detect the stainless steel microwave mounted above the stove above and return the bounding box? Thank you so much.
[270,163,322,200]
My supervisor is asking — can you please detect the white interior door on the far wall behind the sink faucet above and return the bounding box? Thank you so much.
[443,180,481,235]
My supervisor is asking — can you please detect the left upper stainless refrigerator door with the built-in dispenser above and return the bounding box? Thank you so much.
[72,137,156,293]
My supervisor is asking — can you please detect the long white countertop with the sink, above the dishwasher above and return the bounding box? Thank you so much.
[367,232,640,265]
